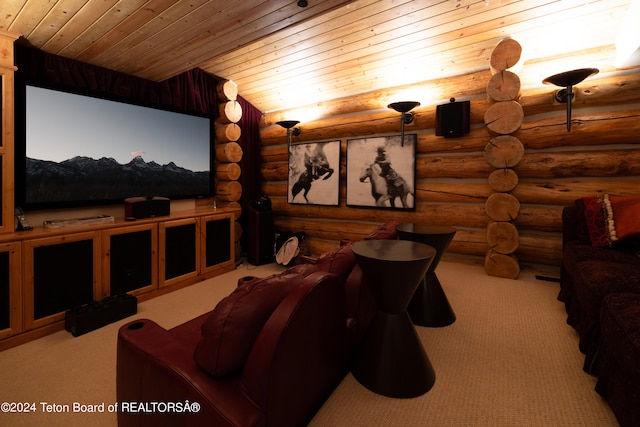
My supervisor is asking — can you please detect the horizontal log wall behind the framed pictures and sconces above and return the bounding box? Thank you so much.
[261,69,640,268]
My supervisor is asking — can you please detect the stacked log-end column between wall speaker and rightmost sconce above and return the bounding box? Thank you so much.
[484,39,524,279]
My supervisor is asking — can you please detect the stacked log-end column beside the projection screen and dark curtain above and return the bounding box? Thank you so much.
[215,80,242,258]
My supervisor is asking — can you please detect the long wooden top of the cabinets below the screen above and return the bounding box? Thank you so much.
[0,207,240,243]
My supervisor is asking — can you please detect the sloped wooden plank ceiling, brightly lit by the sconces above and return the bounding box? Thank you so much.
[0,0,640,112]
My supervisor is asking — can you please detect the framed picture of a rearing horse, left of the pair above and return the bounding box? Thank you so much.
[287,140,340,206]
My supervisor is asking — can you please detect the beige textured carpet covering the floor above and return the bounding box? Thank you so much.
[0,261,617,427]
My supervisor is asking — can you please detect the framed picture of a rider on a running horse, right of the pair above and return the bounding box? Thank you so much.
[347,134,418,210]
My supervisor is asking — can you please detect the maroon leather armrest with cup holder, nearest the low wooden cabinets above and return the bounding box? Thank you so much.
[116,319,262,427]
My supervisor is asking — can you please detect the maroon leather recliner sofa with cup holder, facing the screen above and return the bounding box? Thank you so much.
[116,222,397,427]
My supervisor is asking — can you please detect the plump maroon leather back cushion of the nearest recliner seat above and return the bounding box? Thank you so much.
[193,272,304,378]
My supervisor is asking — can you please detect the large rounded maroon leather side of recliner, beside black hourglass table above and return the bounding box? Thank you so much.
[241,271,347,426]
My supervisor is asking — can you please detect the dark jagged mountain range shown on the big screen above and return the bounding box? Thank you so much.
[26,156,210,203]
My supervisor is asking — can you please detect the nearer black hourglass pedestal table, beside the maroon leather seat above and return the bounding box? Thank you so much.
[351,240,436,398]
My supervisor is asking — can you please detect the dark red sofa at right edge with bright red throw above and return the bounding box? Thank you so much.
[558,196,640,427]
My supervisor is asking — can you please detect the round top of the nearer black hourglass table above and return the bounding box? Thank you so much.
[351,240,436,261]
